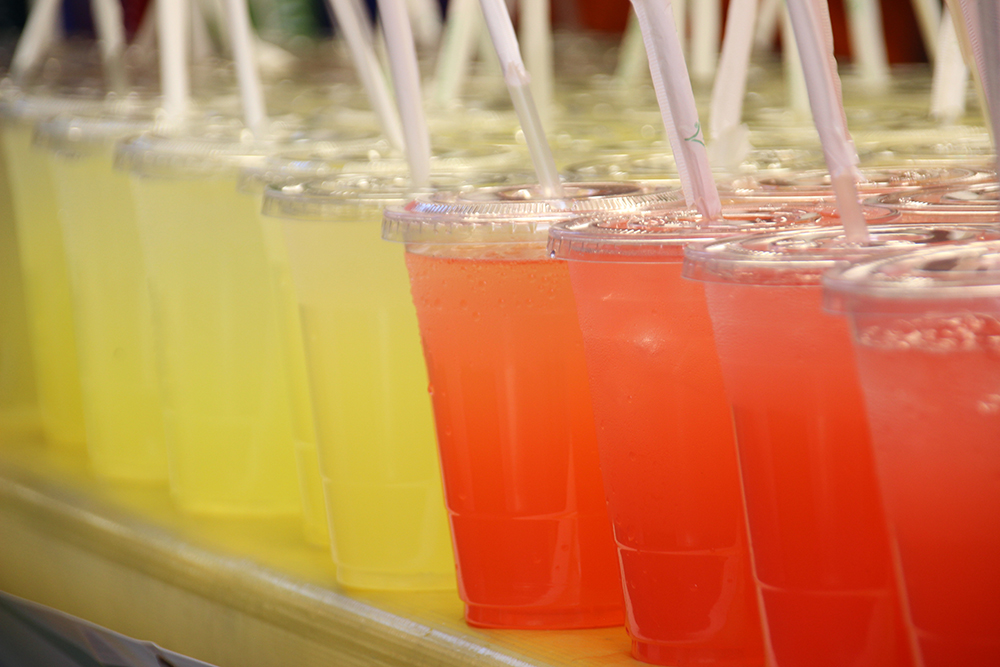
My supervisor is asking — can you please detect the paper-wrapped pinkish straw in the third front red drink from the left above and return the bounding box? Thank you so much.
[788,0,868,243]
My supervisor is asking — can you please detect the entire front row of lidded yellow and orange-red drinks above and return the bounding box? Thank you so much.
[3,77,1000,665]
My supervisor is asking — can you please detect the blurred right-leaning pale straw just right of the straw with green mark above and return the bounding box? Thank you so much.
[708,0,757,166]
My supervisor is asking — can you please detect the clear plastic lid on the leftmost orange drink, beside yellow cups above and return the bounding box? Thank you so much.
[382,183,680,245]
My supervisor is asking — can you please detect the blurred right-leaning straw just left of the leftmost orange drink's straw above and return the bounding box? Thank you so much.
[434,0,483,108]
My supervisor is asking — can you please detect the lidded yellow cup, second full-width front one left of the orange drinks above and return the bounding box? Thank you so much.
[116,124,302,515]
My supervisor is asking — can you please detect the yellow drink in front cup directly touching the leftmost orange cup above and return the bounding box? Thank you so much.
[265,180,455,589]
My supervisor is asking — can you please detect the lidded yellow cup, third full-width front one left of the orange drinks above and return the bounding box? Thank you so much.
[35,111,167,481]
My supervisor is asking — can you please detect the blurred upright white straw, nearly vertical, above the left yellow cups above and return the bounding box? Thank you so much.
[155,0,191,123]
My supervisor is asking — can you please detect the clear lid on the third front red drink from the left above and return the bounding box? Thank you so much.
[684,224,1000,285]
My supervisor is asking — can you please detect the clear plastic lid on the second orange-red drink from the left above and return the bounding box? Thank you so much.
[549,204,820,262]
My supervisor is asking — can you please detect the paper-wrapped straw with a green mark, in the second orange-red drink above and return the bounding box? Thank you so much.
[632,0,722,219]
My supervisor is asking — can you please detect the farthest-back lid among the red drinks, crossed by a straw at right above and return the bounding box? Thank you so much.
[725,166,996,199]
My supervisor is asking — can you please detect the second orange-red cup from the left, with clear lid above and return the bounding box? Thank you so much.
[549,205,836,665]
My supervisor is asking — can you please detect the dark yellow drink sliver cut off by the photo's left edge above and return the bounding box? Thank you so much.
[0,126,41,441]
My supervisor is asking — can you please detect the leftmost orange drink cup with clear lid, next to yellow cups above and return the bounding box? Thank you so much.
[383,183,677,628]
